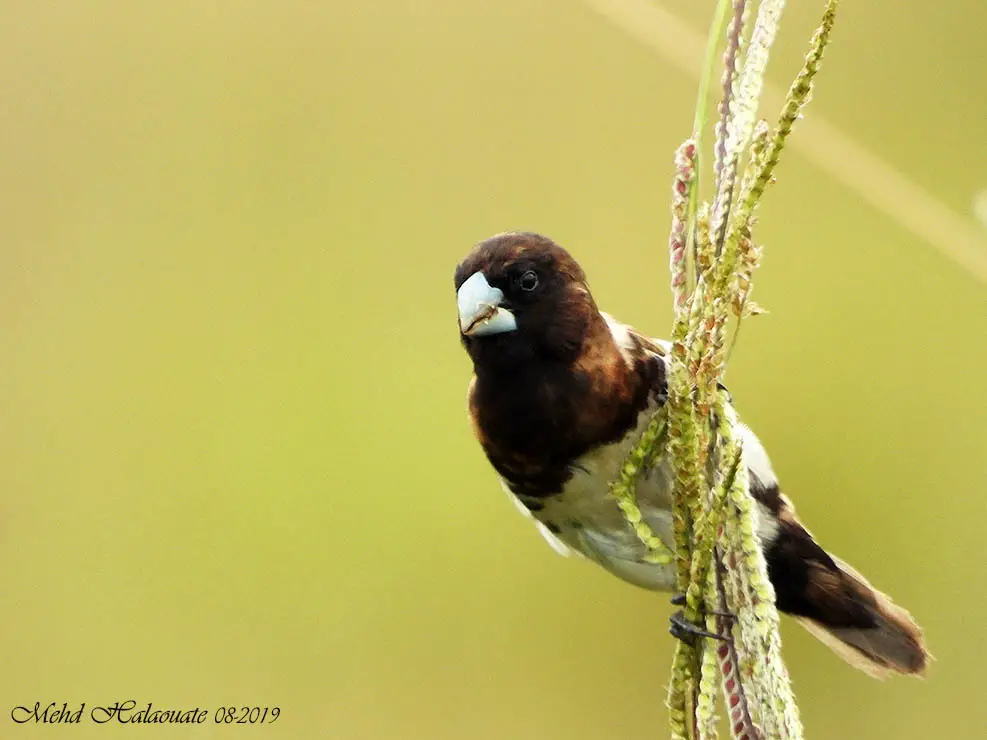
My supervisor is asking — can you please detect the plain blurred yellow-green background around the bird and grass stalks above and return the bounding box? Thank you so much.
[0,0,987,740]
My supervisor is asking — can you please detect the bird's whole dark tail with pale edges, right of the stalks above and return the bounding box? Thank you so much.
[768,511,932,678]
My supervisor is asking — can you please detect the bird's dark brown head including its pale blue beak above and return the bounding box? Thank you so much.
[456,232,603,372]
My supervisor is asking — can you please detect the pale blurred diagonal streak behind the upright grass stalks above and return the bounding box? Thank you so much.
[584,0,987,283]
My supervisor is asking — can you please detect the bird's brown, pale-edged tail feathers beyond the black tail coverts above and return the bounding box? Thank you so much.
[799,558,932,679]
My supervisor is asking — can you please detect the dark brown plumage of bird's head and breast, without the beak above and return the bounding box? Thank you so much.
[456,234,664,497]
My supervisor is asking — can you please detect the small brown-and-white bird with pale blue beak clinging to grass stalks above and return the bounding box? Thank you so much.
[455,232,930,677]
